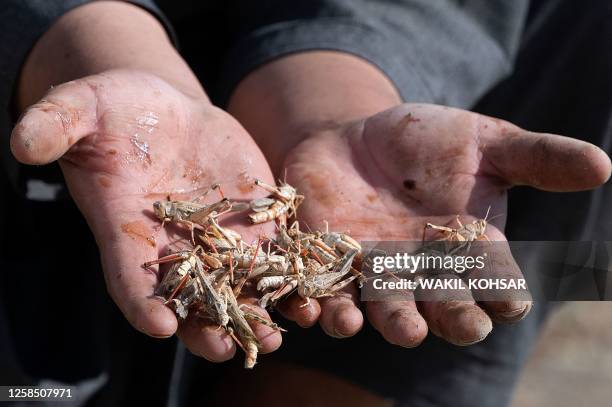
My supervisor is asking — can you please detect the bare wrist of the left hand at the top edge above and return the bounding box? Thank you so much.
[16,1,206,110]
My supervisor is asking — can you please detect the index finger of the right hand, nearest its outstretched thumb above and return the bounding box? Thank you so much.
[466,227,532,322]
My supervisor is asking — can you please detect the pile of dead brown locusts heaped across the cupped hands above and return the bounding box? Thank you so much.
[144,180,364,368]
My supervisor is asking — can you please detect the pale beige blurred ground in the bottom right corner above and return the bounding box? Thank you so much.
[512,302,612,407]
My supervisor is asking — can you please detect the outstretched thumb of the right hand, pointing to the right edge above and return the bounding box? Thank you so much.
[480,118,612,192]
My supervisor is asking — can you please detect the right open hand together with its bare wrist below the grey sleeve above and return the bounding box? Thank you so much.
[229,51,610,346]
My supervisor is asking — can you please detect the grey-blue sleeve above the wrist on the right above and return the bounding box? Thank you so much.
[220,0,529,108]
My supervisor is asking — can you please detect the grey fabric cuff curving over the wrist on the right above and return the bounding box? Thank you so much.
[217,18,433,106]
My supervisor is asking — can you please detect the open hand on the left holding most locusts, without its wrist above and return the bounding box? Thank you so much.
[11,70,281,361]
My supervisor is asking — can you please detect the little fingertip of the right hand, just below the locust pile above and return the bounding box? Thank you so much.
[319,284,363,338]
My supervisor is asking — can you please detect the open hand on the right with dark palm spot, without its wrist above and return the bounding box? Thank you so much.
[285,104,610,347]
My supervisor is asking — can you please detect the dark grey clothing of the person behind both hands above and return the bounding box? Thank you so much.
[0,0,612,407]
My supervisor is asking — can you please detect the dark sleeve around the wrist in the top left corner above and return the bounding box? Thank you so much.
[0,0,176,191]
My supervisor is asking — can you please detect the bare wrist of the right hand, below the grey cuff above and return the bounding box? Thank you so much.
[228,51,401,172]
